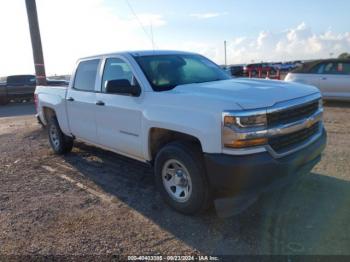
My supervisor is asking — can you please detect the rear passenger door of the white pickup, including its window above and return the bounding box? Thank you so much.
[66,59,100,144]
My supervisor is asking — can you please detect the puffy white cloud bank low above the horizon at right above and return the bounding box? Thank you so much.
[182,23,350,64]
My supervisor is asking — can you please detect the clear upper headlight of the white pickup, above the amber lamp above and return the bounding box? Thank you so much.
[224,114,267,128]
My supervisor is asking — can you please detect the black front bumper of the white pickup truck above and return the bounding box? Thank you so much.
[204,130,327,216]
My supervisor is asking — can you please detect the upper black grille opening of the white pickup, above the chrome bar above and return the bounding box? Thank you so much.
[267,101,319,127]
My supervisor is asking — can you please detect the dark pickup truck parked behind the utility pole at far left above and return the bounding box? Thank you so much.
[0,75,68,105]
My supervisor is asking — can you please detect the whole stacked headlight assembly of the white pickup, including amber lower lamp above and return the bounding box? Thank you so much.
[222,113,267,149]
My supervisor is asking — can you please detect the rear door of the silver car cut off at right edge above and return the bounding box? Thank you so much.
[320,62,350,98]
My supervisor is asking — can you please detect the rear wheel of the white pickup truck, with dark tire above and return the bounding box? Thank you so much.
[47,117,73,155]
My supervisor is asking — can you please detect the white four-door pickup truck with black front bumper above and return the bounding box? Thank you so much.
[35,51,326,214]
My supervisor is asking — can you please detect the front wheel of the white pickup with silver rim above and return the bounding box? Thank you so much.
[155,142,210,215]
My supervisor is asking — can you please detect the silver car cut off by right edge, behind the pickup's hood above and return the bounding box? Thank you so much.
[285,59,350,101]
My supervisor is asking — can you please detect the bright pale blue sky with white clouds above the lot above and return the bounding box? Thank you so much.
[0,0,350,76]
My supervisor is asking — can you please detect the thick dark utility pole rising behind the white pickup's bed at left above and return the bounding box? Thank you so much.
[26,0,46,85]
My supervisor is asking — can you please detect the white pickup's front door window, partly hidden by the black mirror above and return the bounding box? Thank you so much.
[102,58,133,92]
